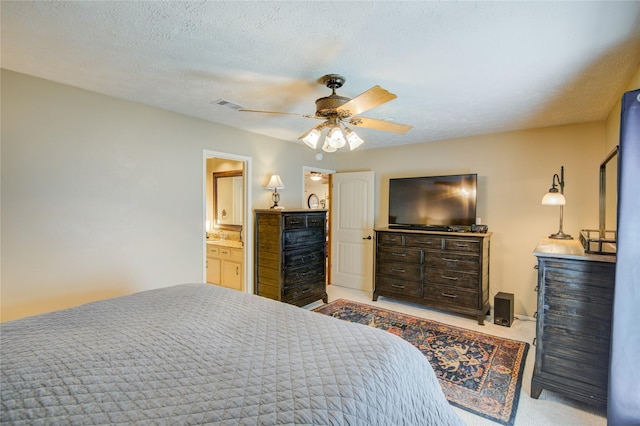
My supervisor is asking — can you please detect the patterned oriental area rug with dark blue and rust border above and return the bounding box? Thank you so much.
[314,299,529,425]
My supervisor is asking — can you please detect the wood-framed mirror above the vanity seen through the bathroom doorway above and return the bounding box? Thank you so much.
[213,170,244,232]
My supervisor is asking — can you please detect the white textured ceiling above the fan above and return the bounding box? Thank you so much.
[1,1,640,149]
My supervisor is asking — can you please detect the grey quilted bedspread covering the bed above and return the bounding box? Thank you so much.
[0,284,462,426]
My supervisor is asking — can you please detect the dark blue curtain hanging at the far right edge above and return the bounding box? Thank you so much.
[607,90,640,426]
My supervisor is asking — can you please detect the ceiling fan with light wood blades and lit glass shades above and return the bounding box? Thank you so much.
[240,74,412,152]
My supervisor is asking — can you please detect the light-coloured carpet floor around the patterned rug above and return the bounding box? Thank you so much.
[308,285,607,426]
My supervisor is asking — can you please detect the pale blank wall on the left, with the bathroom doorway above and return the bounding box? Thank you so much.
[0,70,334,320]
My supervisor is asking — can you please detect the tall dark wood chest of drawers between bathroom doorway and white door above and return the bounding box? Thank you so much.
[255,209,328,306]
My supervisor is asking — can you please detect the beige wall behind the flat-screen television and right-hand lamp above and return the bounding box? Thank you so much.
[337,122,605,316]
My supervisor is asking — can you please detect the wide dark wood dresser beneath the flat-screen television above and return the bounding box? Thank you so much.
[373,228,491,325]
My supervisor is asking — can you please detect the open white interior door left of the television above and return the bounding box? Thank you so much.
[331,172,374,292]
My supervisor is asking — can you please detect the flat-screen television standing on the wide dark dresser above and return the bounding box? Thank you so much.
[389,174,478,229]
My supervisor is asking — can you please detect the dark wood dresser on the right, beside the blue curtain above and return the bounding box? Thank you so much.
[531,238,616,407]
